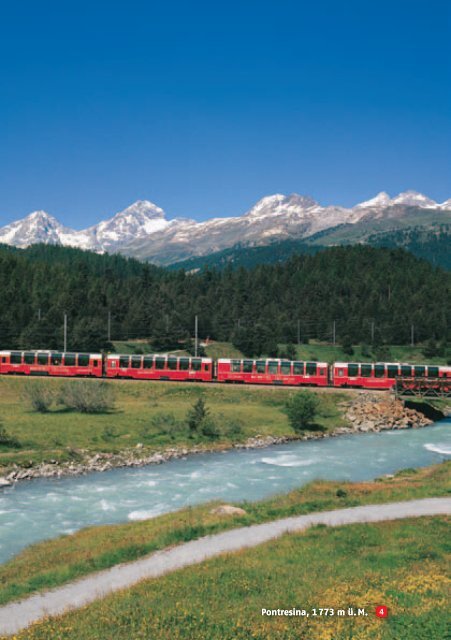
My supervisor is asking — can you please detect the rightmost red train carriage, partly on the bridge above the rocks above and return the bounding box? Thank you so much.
[332,362,451,389]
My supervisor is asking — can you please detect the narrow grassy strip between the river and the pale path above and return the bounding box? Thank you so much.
[0,462,451,608]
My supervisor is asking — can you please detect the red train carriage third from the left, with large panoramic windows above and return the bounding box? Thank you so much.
[217,358,329,387]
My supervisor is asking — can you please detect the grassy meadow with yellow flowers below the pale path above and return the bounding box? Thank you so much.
[10,517,451,640]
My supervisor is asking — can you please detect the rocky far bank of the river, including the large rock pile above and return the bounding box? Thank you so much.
[0,393,444,488]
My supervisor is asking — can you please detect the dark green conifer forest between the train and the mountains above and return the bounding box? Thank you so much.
[0,245,451,356]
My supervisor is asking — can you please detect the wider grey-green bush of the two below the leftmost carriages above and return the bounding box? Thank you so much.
[60,380,115,413]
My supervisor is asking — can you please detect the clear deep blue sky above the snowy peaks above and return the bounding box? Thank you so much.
[0,0,451,228]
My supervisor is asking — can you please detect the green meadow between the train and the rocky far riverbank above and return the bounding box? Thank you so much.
[0,376,350,475]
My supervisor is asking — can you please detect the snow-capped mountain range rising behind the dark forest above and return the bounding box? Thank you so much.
[0,191,451,264]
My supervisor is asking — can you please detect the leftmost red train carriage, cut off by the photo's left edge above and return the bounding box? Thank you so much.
[0,350,103,378]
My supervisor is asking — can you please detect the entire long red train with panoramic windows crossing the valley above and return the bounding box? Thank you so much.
[0,350,451,391]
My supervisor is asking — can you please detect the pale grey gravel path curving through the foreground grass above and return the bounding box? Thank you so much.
[0,498,451,636]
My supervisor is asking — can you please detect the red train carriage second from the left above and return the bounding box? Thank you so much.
[105,354,213,382]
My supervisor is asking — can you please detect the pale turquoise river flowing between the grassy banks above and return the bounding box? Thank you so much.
[0,419,451,562]
